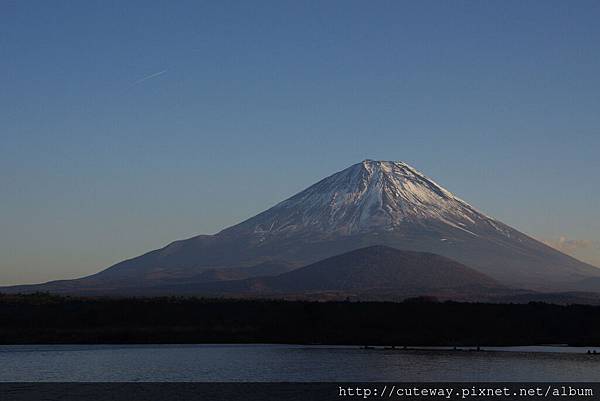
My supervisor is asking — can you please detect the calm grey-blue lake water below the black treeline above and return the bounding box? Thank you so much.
[0,345,600,382]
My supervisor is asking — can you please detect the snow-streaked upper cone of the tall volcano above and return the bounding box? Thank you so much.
[230,159,501,236]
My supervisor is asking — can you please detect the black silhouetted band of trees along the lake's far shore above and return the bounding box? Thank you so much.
[0,294,600,346]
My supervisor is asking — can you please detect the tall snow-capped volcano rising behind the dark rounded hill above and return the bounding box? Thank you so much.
[2,160,600,291]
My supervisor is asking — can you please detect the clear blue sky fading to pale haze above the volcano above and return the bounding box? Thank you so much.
[0,0,600,284]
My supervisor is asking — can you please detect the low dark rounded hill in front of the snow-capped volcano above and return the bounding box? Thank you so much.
[131,245,510,300]
